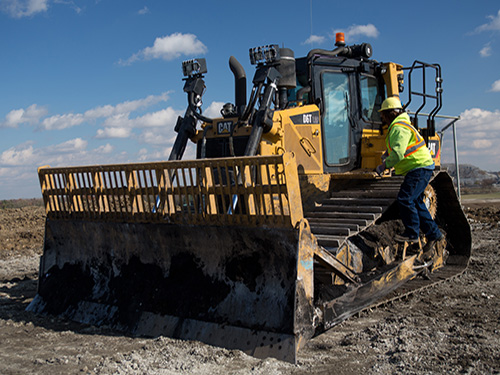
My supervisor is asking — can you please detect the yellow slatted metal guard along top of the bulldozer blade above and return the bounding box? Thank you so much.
[38,154,303,227]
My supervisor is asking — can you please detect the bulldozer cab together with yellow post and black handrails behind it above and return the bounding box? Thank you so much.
[290,48,442,173]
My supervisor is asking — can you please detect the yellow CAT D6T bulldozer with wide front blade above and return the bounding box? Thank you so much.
[28,35,471,362]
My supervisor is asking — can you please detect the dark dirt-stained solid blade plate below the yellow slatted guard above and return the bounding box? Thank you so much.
[26,220,312,362]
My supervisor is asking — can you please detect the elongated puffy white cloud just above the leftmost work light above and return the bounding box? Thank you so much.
[119,33,208,65]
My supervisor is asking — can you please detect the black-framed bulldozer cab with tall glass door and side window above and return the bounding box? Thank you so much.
[297,55,386,173]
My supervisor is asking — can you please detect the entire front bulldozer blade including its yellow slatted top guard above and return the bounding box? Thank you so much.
[28,155,314,362]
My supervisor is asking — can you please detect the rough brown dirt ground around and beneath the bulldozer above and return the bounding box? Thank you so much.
[0,201,500,374]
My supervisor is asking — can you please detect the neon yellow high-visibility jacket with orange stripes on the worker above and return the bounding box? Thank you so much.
[385,113,434,175]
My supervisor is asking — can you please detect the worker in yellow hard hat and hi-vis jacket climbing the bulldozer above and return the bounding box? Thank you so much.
[376,97,443,261]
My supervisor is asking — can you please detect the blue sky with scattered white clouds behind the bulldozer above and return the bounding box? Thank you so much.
[0,0,500,199]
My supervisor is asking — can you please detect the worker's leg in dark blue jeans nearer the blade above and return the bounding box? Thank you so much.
[397,168,432,238]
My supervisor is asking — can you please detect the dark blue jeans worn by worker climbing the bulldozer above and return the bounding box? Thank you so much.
[397,168,442,240]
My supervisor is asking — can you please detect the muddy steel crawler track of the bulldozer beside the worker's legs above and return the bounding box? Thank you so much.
[305,173,470,329]
